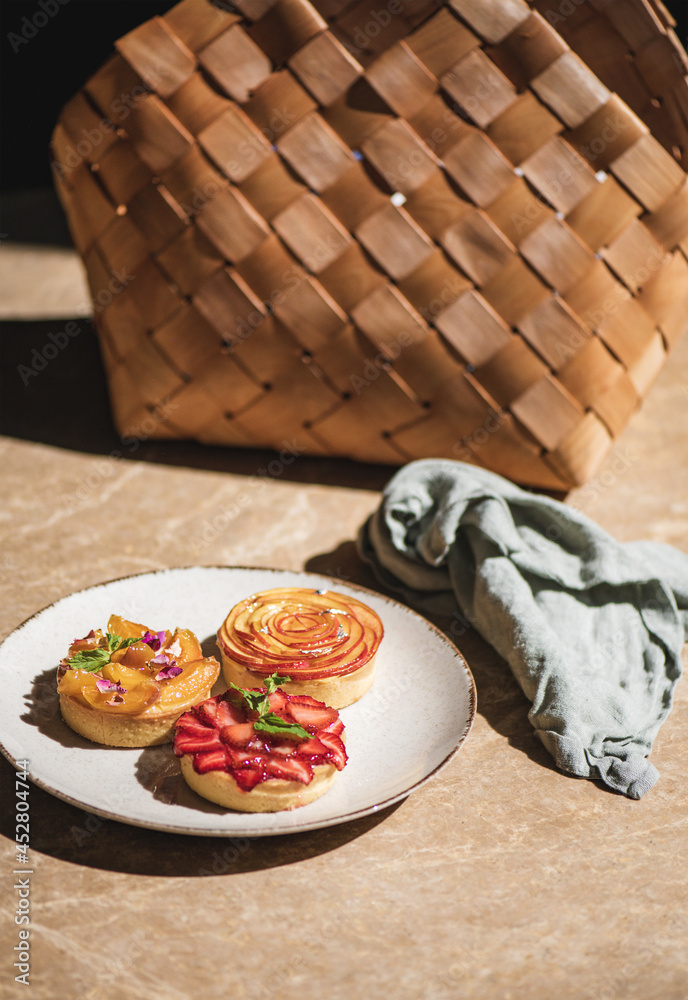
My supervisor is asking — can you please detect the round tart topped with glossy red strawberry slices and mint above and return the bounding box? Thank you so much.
[174,674,347,812]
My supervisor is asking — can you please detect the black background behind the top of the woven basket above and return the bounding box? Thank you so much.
[0,0,688,195]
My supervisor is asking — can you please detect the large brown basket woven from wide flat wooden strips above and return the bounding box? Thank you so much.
[52,0,688,489]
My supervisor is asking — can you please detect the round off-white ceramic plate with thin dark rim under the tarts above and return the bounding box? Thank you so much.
[0,567,476,837]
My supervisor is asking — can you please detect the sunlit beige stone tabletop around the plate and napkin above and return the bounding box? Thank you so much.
[0,324,688,1000]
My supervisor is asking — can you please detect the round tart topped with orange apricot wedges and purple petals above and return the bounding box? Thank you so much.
[57,615,220,747]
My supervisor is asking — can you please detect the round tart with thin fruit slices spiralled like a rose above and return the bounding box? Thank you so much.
[217,587,384,708]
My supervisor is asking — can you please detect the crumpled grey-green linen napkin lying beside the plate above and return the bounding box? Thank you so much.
[359,459,688,799]
